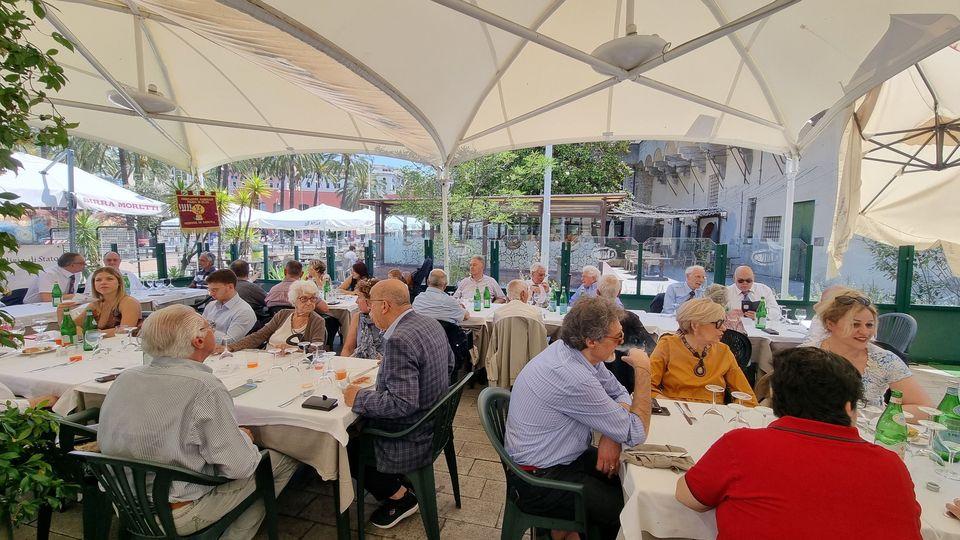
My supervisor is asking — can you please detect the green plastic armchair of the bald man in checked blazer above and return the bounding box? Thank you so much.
[357,373,473,540]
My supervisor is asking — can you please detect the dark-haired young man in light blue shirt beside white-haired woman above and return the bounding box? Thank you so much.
[203,269,257,345]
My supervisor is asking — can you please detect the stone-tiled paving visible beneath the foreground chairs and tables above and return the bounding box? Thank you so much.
[14,366,950,540]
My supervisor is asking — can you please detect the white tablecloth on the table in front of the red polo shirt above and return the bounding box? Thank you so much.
[620,399,960,540]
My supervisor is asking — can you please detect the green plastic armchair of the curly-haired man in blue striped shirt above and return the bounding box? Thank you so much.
[477,387,599,540]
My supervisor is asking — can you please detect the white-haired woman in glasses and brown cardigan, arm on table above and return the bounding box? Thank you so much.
[214,281,327,352]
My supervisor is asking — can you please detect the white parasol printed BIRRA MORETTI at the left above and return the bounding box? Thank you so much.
[0,152,167,216]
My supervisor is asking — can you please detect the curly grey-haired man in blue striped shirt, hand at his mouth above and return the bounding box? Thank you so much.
[506,298,650,538]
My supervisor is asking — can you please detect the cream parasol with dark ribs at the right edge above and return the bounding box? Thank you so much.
[828,44,960,276]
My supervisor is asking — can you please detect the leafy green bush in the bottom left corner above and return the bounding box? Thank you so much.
[0,407,79,540]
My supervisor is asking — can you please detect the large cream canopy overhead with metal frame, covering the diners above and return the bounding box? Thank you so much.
[24,0,960,279]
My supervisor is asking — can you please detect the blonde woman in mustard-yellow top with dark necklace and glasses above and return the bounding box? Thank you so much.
[650,298,757,406]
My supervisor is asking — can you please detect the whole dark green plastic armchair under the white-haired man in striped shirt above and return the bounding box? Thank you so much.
[70,450,279,540]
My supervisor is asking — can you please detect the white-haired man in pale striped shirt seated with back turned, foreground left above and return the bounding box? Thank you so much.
[97,305,298,539]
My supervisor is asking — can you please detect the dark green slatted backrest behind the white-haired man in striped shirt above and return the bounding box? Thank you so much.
[70,451,230,538]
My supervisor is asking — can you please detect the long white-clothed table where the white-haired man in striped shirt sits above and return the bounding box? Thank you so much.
[0,336,377,530]
